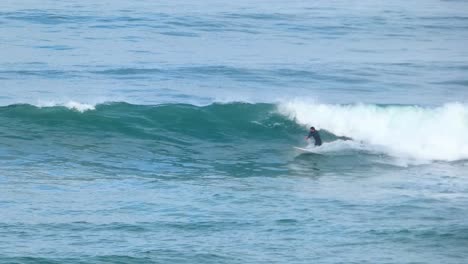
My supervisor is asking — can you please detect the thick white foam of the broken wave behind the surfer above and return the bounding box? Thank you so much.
[278,101,468,161]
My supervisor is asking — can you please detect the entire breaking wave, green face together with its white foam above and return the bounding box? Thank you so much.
[0,101,468,161]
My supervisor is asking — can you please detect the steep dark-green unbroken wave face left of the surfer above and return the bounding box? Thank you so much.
[0,102,303,141]
